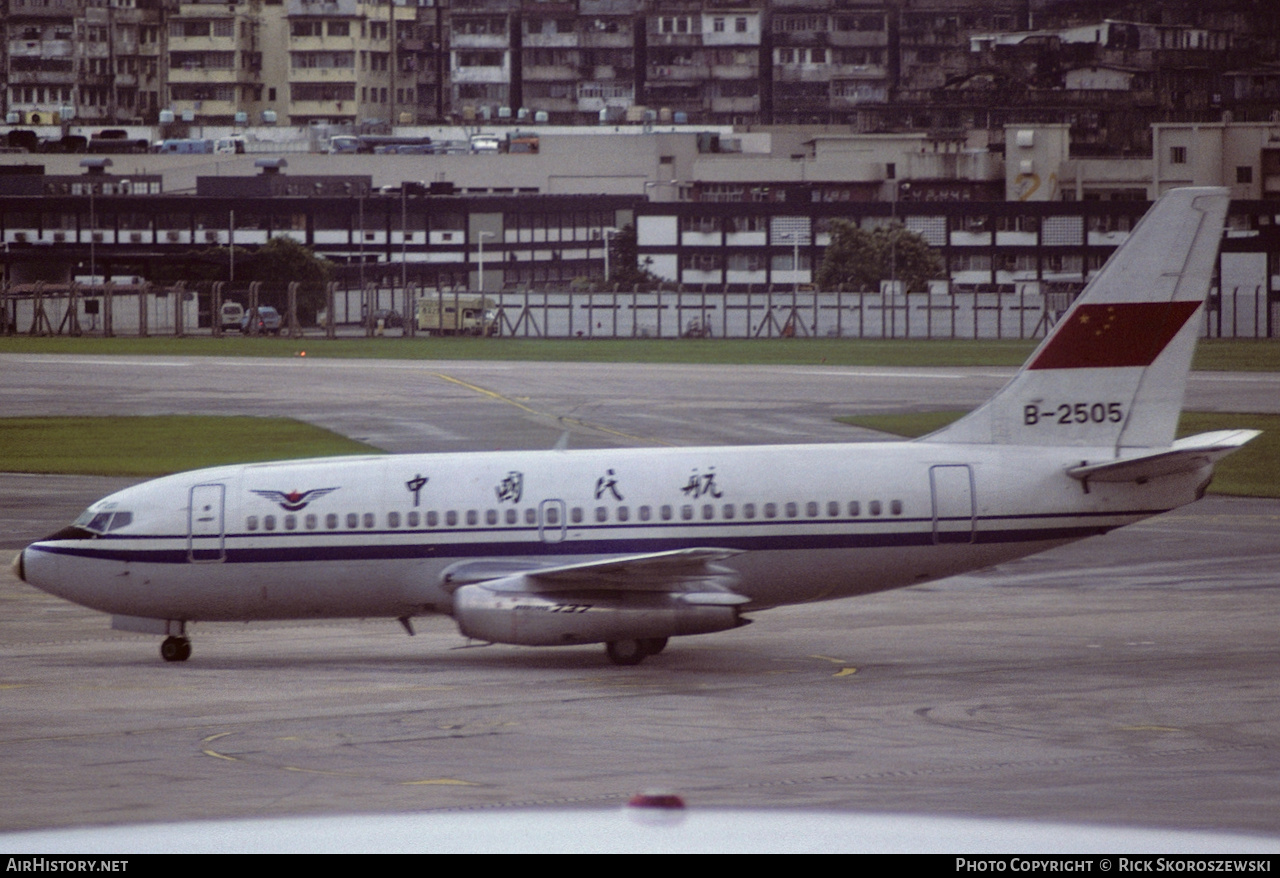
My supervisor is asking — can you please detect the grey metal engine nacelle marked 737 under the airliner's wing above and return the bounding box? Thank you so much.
[453,585,742,646]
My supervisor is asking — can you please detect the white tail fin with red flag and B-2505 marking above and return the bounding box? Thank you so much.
[924,188,1229,447]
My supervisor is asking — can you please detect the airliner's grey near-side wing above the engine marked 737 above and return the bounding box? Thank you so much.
[444,547,748,604]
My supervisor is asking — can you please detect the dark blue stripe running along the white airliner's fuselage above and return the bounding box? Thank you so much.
[33,513,1132,564]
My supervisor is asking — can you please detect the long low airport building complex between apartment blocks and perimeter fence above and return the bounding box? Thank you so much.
[0,123,1280,335]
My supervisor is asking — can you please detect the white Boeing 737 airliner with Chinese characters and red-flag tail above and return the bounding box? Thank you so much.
[14,188,1257,664]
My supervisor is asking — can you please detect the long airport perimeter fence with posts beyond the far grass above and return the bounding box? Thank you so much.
[0,283,1280,339]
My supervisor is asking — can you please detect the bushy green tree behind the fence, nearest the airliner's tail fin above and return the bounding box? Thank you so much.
[815,220,942,292]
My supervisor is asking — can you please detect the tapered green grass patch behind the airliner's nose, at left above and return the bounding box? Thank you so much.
[0,415,378,476]
